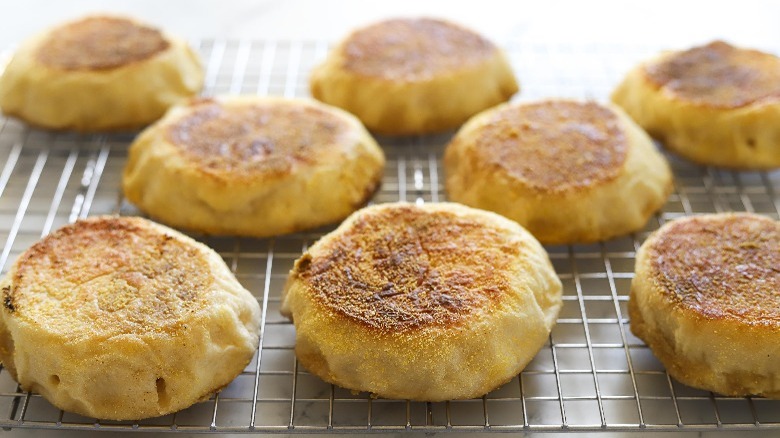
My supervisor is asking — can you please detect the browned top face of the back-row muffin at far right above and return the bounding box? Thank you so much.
[645,41,780,108]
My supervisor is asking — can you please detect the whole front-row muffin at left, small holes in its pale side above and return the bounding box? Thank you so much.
[0,216,260,420]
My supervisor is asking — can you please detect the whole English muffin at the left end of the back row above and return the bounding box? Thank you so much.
[0,16,203,132]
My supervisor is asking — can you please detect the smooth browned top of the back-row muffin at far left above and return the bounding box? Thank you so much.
[37,16,170,70]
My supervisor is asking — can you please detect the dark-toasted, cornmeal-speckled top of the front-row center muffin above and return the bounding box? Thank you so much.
[293,204,522,332]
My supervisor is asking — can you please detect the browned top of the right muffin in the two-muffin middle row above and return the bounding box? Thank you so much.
[470,100,628,193]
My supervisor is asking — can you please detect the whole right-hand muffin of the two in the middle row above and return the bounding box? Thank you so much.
[444,100,672,244]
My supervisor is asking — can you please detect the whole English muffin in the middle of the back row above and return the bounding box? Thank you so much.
[310,18,518,135]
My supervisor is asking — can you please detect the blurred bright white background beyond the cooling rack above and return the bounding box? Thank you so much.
[0,0,780,48]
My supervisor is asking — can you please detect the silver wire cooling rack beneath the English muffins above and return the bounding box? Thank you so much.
[0,40,780,433]
